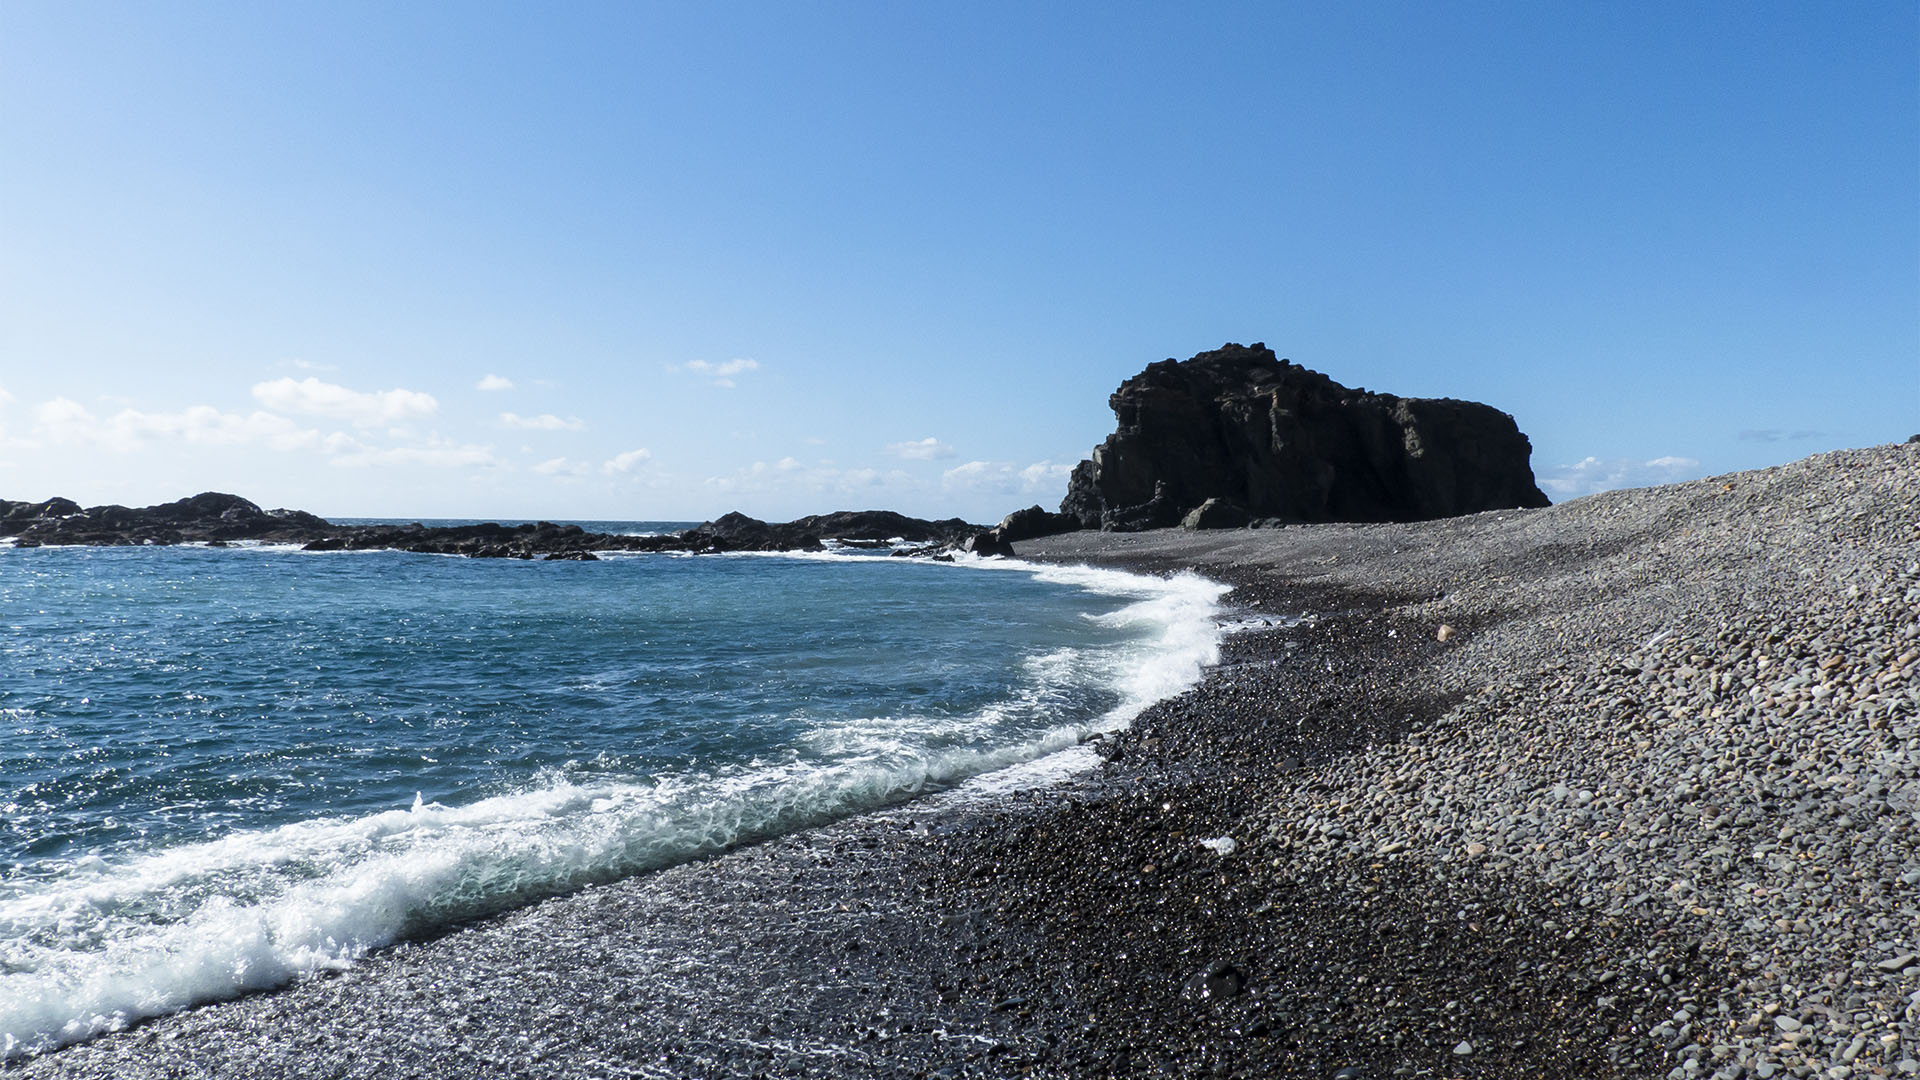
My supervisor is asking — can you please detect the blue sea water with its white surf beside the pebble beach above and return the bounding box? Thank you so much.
[0,523,1225,1059]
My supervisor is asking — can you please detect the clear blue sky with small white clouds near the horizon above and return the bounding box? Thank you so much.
[0,0,1920,521]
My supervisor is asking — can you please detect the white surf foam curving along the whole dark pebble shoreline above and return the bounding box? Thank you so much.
[0,555,1225,1059]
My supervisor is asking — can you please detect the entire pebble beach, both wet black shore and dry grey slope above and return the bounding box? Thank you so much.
[18,446,1920,1078]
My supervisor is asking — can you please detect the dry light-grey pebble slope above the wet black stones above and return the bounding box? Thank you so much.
[1013,438,1920,1080]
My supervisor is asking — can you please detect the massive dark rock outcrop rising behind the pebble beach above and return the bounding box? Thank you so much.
[1060,342,1548,530]
